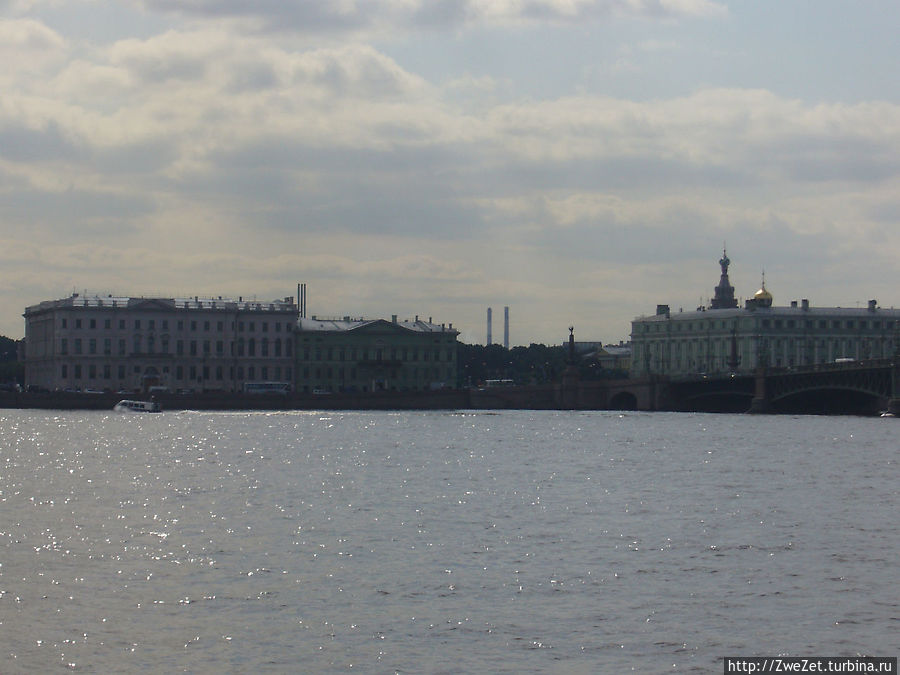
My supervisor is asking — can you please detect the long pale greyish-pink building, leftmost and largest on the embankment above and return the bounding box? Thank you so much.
[24,294,298,392]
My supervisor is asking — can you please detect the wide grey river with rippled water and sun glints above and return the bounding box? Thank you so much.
[0,410,900,673]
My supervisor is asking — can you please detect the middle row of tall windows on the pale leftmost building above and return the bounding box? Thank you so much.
[59,335,292,358]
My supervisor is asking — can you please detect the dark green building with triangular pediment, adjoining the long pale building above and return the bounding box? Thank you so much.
[296,316,459,393]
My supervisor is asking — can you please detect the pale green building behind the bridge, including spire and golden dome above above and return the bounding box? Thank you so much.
[631,256,900,377]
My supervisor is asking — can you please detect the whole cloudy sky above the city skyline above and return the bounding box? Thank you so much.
[0,0,900,345]
